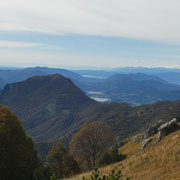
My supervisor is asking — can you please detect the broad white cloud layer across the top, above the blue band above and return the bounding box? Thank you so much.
[0,0,180,43]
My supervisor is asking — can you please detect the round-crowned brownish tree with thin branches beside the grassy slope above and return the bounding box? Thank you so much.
[70,122,115,169]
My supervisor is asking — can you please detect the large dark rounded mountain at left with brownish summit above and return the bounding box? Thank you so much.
[0,74,96,139]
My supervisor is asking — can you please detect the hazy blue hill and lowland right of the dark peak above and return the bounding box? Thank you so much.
[79,73,180,105]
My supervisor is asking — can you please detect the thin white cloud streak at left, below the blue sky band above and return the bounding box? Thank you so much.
[0,40,63,50]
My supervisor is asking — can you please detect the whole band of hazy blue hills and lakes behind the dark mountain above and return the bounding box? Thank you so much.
[0,67,180,106]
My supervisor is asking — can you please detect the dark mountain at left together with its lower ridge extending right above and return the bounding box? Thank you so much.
[0,74,180,143]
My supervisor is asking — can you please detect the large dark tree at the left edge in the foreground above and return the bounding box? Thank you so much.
[0,106,40,180]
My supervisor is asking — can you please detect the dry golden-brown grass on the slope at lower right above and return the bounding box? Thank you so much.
[66,131,180,180]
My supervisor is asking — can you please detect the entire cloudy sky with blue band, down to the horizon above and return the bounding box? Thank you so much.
[0,0,180,68]
